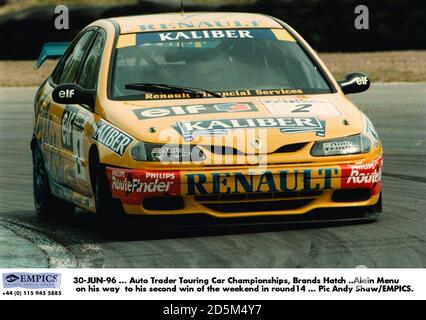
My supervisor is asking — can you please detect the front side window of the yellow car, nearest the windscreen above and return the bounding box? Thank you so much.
[78,32,105,89]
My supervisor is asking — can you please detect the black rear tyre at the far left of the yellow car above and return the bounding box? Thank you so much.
[33,143,75,221]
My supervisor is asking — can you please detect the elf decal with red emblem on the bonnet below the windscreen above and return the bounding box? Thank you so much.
[133,102,257,120]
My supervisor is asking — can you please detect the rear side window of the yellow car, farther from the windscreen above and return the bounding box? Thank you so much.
[58,31,94,84]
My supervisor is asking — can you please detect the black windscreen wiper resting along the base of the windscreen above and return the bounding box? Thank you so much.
[124,83,222,98]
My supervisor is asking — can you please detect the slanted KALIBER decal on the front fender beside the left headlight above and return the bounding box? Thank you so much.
[92,120,133,157]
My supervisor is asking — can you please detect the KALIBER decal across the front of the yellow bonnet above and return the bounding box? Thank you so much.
[175,117,325,141]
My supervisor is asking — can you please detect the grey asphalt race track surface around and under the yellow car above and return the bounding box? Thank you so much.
[0,83,426,268]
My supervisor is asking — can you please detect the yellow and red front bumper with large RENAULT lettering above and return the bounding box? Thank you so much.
[106,157,383,218]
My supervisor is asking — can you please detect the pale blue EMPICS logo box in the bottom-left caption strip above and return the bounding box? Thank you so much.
[3,272,61,289]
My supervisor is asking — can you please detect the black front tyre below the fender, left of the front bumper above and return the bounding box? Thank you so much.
[94,163,125,232]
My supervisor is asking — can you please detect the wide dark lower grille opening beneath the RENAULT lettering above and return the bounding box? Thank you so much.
[203,199,313,213]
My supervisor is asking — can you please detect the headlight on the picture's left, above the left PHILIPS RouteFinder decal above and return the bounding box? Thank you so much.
[130,142,205,163]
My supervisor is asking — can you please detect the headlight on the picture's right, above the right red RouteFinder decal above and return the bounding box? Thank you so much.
[311,133,372,157]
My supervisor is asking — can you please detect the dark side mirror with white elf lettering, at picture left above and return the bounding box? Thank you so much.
[52,83,95,108]
